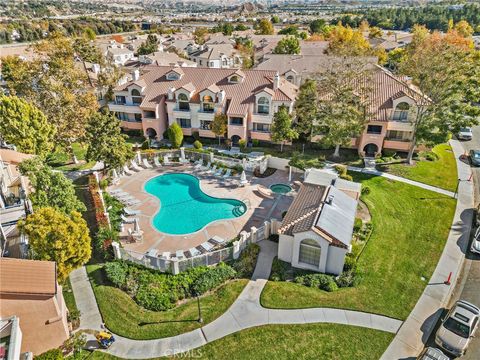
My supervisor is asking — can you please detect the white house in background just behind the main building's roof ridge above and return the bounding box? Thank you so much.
[188,43,242,69]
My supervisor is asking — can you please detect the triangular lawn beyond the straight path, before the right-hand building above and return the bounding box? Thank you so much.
[378,144,457,191]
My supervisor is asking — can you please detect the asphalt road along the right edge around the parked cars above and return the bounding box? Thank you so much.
[427,126,480,360]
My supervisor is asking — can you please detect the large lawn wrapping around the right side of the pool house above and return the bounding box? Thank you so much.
[261,174,455,319]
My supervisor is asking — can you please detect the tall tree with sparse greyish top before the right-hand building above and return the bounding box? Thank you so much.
[312,59,371,157]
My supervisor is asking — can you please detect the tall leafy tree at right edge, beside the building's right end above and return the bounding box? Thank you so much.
[400,32,480,163]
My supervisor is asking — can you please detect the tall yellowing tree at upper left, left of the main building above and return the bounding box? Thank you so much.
[1,33,98,160]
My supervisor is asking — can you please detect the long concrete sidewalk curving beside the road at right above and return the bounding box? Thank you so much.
[382,140,474,360]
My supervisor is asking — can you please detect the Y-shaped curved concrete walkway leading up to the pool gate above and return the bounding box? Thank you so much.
[71,240,402,359]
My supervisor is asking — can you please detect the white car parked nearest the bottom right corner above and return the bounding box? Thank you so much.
[435,300,480,356]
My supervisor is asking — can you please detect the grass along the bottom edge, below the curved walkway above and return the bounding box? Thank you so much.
[78,324,394,360]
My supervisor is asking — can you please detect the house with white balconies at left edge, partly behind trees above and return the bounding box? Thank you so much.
[0,149,32,258]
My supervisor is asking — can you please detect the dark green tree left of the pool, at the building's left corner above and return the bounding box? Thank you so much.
[86,113,135,170]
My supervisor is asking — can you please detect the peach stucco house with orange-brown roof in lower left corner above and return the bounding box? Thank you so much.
[0,258,70,355]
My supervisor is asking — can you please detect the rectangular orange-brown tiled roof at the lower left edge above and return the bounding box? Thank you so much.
[0,258,57,295]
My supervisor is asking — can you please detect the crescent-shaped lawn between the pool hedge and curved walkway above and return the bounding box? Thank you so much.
[87,265,248,339]
